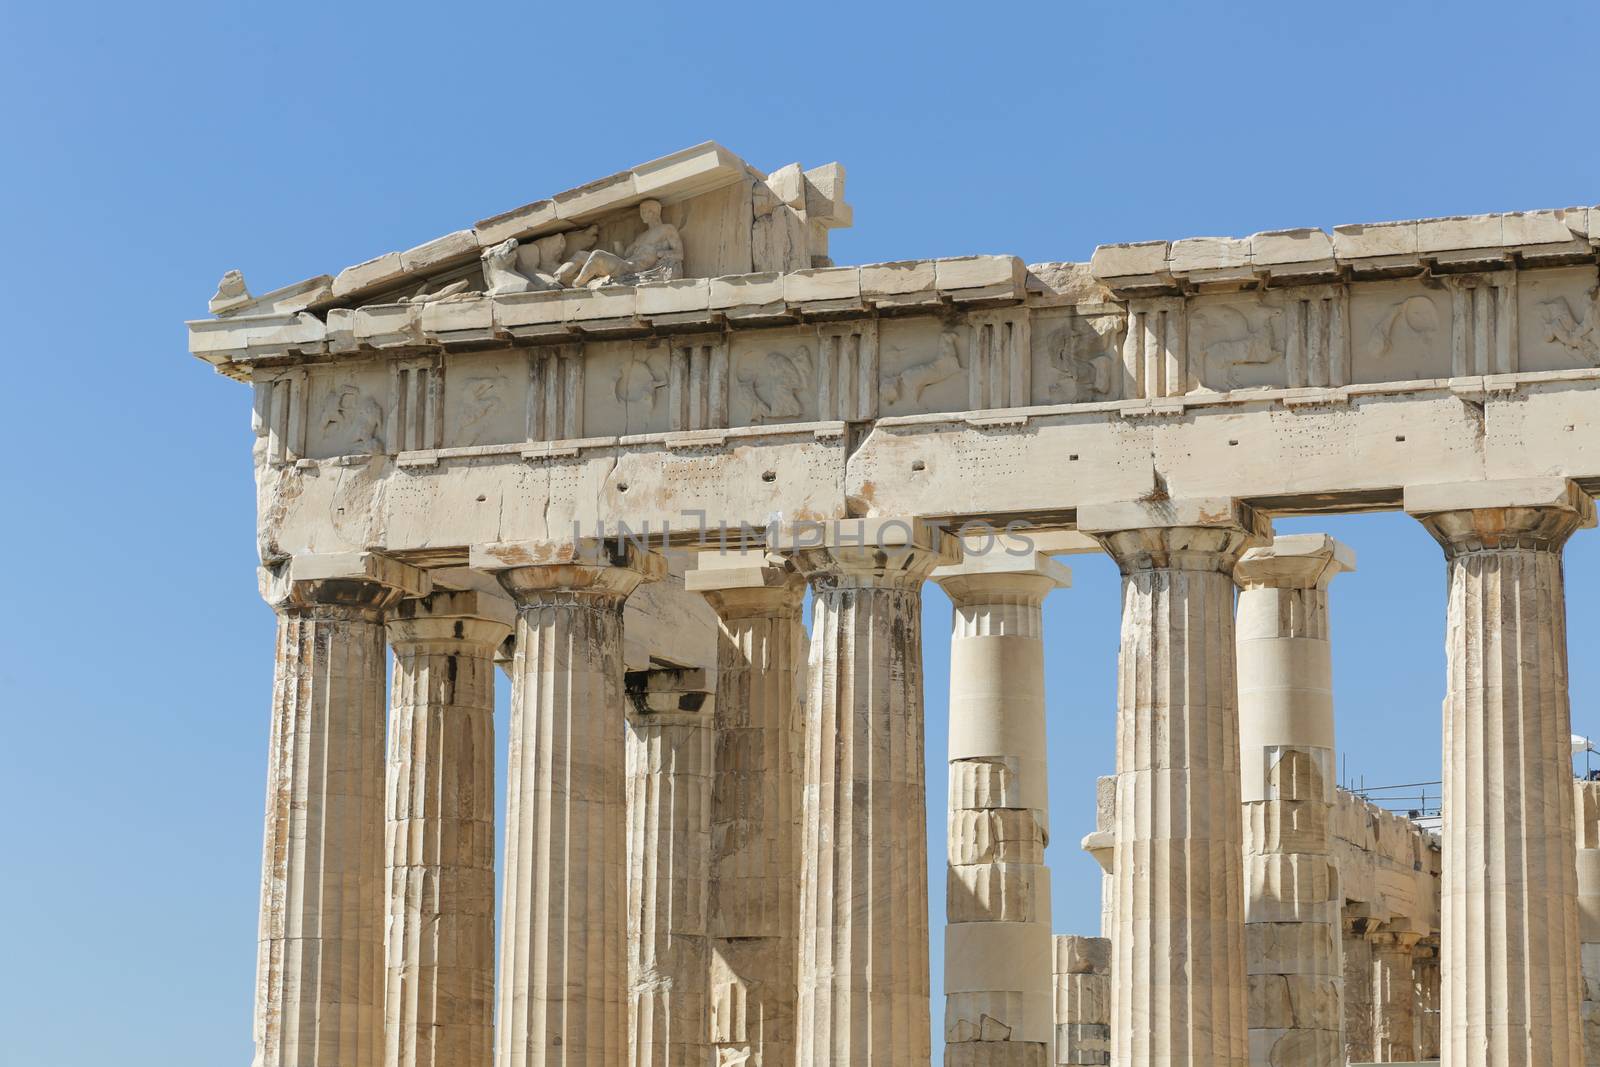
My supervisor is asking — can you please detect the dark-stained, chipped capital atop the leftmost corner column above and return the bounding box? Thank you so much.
[256,552,434,619]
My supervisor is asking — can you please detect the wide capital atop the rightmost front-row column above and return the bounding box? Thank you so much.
[1405,478,1595,558]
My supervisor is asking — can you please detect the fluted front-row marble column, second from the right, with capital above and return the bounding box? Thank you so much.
[1078,501,1266,1067]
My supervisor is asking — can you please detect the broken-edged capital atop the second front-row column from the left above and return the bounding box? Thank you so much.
[470,537,667,606]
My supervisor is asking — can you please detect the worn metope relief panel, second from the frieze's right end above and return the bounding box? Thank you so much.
[1350,280,1450,384]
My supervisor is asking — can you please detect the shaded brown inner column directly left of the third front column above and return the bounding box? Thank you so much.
[683,553,806,1067]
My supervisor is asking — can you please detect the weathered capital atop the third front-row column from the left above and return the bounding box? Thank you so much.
[768,518,962,589]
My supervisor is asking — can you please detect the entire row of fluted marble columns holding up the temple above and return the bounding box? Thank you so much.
[243,483,1592,1067]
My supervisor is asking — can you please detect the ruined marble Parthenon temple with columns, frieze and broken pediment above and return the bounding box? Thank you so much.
[189,142,1600,1067]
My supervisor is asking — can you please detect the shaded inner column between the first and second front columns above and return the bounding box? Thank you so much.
[384,592,512,1067]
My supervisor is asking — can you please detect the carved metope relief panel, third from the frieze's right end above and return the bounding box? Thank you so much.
[1190,291,1304,397]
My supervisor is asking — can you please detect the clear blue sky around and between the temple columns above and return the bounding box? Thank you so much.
[0,0,1600,1067]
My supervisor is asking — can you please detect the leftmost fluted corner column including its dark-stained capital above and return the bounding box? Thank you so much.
[253,553,429,1067]
